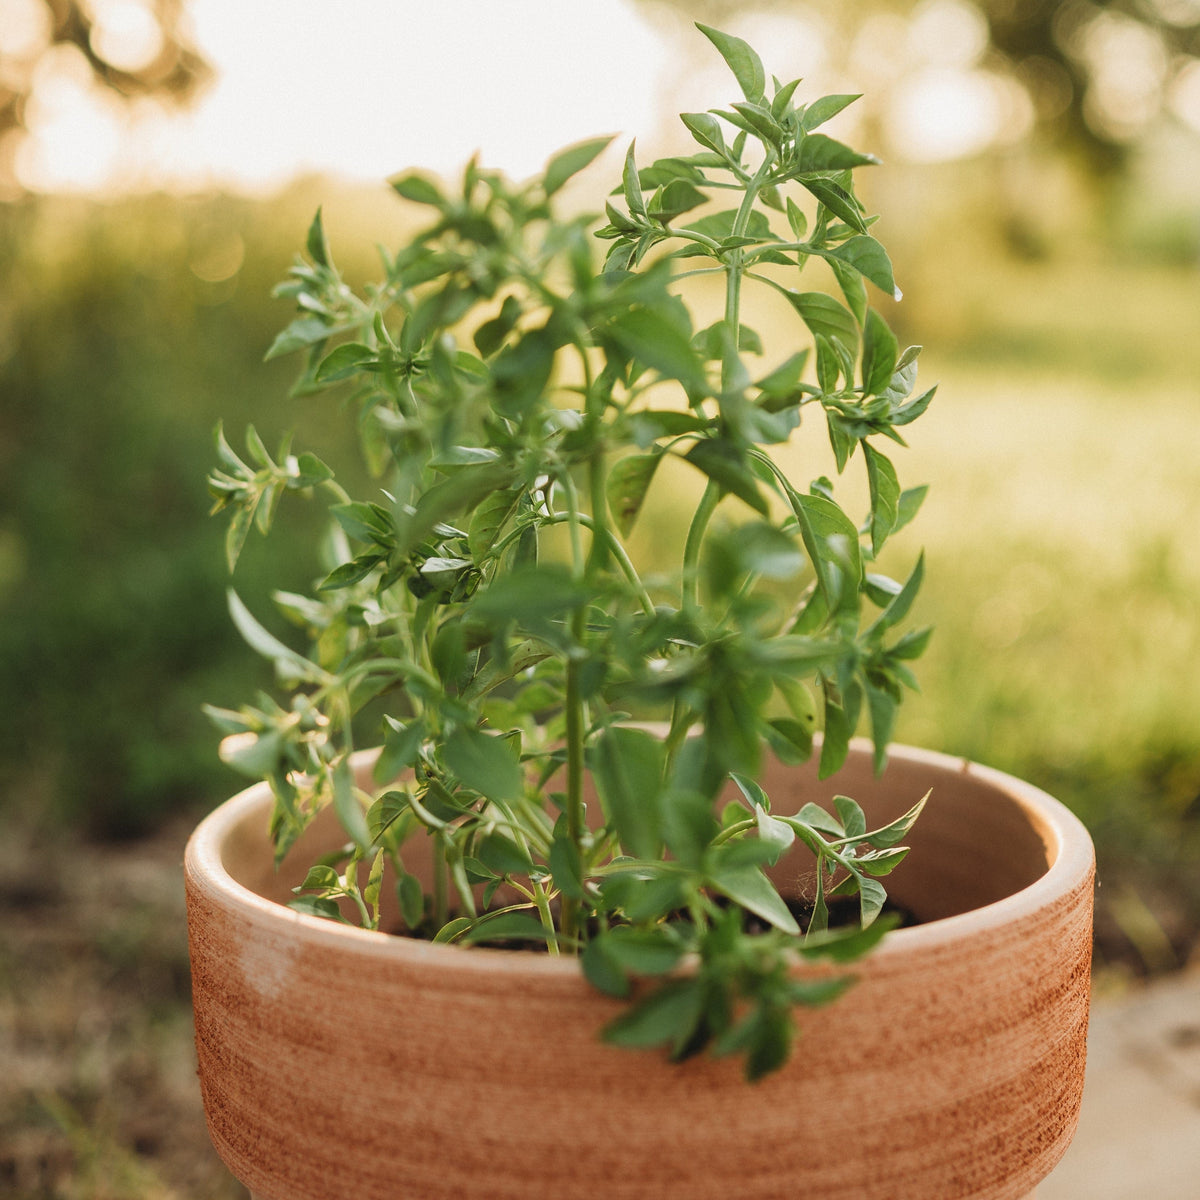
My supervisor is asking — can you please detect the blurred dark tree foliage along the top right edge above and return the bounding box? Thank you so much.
[641,0,1200,176]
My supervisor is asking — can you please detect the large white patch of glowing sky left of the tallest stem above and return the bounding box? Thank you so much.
[16,0,668,190]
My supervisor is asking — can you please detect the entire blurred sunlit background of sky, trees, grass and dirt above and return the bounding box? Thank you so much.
[0,0,1200,1200]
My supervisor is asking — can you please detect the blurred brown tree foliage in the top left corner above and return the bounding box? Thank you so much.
[0,0,209,196]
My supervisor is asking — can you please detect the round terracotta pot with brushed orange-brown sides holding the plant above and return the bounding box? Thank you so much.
[186,745,1093,1200]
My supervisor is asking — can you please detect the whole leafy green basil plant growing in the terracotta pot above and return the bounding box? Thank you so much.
[209,25,932,1078]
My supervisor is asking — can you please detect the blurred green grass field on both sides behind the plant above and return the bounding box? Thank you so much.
[0,177,1200,953]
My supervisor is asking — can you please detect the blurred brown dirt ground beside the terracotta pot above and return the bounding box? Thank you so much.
[0,818,1196,1200]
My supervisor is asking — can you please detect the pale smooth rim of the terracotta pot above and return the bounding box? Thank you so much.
[184,738,1094,978]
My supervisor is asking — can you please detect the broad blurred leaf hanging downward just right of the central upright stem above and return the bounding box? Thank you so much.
[592,725,665,858]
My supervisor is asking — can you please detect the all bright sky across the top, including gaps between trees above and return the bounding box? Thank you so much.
[18,0,1200,191]
